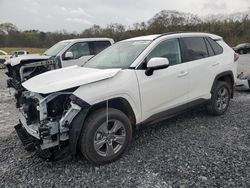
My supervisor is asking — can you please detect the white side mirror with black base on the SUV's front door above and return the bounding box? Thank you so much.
[145,57,169,76]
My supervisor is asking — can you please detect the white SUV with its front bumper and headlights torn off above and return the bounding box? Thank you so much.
[15,33,237,164]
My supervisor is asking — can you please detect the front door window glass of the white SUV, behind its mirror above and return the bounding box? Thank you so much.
[146,39,181,66]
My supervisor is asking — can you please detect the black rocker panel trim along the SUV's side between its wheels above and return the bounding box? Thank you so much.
[140,99,209,125]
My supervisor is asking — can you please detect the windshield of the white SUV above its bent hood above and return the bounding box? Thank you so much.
[84,41,151,69]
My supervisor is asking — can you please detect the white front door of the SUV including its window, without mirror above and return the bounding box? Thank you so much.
[136,39,189,120]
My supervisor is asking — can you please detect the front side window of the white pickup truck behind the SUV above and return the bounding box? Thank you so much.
[67,42,90,59]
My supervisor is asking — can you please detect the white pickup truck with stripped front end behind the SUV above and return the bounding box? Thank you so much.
[6,38,114,107]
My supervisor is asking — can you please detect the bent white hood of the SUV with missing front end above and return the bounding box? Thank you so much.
[22,66,121,94]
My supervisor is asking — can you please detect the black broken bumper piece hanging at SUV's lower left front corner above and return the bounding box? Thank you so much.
[15,124,36,152]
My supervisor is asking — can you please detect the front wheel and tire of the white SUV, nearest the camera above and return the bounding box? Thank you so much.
[79,108,132,165]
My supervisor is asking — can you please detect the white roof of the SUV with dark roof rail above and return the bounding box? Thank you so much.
[124,32,222,41]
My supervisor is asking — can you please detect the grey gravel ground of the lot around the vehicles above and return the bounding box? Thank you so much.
[0,56,250,187]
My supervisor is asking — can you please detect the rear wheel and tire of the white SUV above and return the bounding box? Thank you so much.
[207,81,232,116]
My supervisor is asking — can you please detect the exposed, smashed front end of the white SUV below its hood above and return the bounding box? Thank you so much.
[15,91,89,159]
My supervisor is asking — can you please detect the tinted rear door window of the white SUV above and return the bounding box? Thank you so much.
[182,37,208,61]
